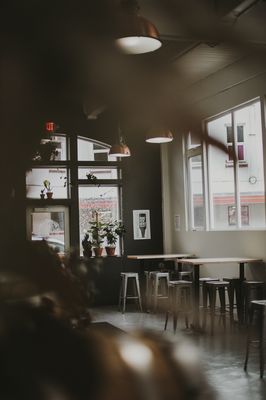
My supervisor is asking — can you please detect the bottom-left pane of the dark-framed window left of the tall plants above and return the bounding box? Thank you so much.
[30,207,67,253]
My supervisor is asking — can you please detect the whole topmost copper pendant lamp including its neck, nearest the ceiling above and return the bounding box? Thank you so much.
[116,0,162,54]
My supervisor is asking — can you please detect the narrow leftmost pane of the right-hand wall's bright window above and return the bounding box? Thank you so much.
[189,155,205,229]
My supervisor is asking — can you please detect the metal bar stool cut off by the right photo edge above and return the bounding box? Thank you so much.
[244,300,266,378]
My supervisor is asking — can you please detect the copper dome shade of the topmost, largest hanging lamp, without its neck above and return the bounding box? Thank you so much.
[116,15,162,54]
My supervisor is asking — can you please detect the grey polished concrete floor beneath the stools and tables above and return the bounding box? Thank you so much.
[90,306,266,400]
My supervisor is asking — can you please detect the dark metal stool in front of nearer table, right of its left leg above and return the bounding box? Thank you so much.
[203,281,229,335]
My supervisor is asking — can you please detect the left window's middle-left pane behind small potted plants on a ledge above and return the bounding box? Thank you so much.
[26,168,68,199]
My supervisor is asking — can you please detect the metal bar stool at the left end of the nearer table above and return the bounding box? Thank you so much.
[164,280,193,332]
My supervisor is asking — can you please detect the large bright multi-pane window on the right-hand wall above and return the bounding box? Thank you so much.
[186,100,265,230]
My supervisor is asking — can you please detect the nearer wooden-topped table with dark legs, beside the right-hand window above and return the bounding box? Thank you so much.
[179,257,262,329]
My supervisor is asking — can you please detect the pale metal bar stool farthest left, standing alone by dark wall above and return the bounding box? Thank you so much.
[118,272,142,314]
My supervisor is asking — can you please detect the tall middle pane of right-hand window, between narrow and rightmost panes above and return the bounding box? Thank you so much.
[207,114,235,229]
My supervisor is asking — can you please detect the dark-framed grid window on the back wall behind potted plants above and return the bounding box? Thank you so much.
[26,134,122,254]
